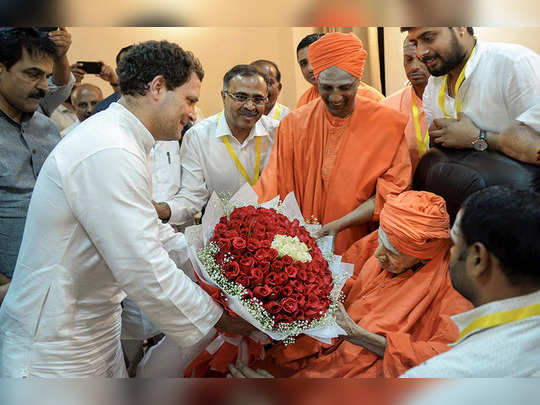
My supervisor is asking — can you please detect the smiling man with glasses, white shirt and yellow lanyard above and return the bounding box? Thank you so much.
[154,65,279,225]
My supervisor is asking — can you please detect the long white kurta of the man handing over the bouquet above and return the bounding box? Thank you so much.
[0,103,222,377]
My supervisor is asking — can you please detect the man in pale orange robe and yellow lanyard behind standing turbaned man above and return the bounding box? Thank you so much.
[381,37,429,171]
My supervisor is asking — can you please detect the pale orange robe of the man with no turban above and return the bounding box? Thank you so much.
[381,86,427,172]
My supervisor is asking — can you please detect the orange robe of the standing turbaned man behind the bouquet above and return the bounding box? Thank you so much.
[254,96,411,254]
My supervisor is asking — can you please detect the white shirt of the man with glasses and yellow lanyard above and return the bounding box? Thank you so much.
[167,111,279,225]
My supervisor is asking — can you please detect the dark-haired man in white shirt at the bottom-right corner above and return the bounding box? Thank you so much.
[403,186,540,378]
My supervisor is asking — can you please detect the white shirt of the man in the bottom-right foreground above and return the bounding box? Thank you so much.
[402,291,540,378]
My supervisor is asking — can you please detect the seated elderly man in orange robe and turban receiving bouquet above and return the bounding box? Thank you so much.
[230,191,472,378]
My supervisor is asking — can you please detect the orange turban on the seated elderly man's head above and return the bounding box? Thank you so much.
[380,191,450,260]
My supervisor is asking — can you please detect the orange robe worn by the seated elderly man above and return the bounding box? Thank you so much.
[258,237,472,378]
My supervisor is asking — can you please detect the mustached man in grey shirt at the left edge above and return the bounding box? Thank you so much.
[0,27,60,278]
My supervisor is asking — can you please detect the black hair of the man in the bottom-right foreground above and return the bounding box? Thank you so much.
[460,186,540,286]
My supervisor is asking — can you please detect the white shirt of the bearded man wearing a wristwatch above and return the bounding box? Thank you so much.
[423,40,540,133]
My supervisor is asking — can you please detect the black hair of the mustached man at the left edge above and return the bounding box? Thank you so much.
[0,27,58,70]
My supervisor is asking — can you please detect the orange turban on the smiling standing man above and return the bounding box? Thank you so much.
[308,32,367,79]
